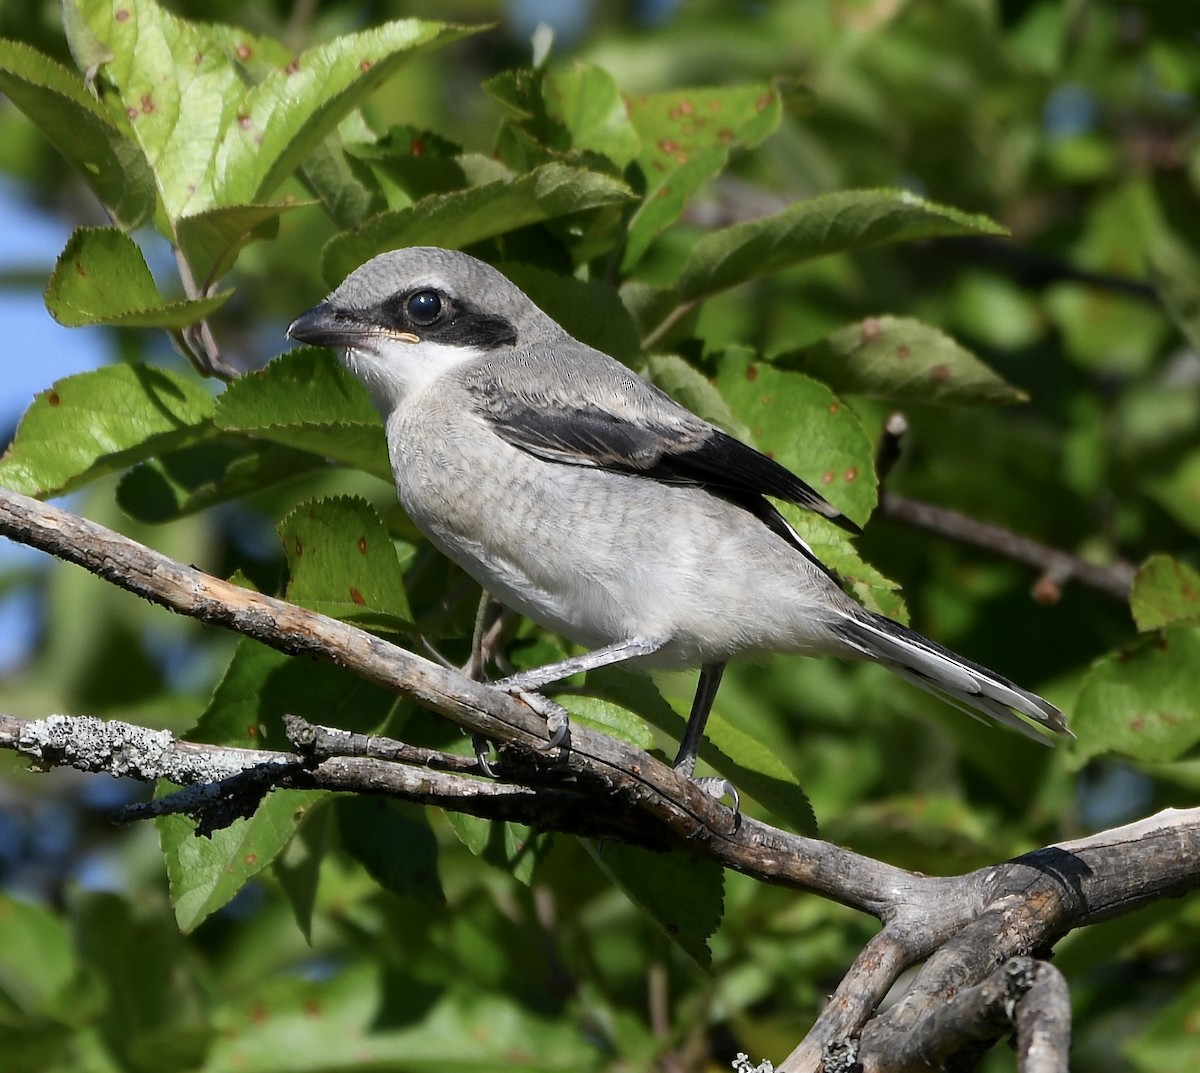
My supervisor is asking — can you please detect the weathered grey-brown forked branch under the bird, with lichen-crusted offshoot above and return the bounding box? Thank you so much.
[0,490,1200,1073]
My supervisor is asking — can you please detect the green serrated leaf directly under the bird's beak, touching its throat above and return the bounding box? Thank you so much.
[215,347,392,484]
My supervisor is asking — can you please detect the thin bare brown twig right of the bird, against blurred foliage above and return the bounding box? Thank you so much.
[880,492,1136,604]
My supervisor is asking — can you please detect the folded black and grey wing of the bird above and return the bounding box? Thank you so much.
[472,385,863,543]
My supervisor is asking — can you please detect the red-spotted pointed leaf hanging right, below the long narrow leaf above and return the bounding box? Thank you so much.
[772,317,1027,403]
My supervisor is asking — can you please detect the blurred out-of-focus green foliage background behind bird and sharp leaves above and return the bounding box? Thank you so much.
[0,0,1200,1073]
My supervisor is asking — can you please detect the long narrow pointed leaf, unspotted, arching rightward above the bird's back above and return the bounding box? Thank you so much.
[671,190,1004,312]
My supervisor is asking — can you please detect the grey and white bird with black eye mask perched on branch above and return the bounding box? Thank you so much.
[287,246,1070,796]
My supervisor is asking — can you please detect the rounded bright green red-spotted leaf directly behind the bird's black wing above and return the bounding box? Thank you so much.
[716,348,876,524]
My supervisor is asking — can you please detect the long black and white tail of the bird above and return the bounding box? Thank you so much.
[835,612,1074,744]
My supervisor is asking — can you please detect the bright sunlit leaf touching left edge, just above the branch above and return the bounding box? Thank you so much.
[0,365,212,496]
